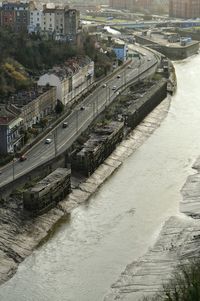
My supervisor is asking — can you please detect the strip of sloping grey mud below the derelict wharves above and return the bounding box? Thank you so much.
[0,97,170,283]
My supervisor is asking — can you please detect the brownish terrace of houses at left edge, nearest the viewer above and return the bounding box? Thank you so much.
[0,86,57,154]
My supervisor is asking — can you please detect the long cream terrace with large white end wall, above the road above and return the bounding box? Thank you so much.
[37,57,94,105]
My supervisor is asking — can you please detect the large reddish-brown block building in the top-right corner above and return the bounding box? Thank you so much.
[169,0,200,19]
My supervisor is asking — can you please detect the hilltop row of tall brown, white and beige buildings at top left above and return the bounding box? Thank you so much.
[0,1,80,37]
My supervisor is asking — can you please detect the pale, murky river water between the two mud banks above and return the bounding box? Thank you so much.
[0,55,200,301]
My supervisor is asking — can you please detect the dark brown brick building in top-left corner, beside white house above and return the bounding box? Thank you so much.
[0,2,30,31]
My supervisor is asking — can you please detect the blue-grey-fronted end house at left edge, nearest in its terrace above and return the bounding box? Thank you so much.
[0,105,23,154]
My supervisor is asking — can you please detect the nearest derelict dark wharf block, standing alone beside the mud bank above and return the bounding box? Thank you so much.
[23,168,71,215]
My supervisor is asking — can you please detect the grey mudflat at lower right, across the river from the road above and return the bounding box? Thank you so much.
[104,157,200,301]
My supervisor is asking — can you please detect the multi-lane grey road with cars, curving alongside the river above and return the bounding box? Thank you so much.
[0,50,157,187]
